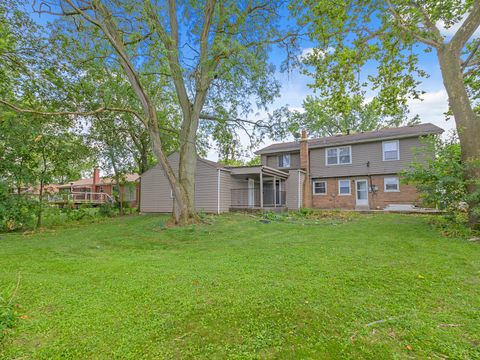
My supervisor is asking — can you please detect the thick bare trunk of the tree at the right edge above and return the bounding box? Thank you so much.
[437,44,480,227]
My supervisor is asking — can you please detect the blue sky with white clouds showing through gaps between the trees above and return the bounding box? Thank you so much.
[28,4,464,160]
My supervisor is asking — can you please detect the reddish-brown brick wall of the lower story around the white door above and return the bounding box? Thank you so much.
[310,174,418,209]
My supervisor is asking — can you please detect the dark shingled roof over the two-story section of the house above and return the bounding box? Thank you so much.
[255,123,443,155]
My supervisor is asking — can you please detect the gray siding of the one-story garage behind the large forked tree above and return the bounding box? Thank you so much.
[140,153,230,213]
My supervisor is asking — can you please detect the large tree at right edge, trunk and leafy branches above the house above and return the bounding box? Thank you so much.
[293,0,480,225]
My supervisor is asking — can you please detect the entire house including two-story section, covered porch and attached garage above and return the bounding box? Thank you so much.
[141,123,443,213]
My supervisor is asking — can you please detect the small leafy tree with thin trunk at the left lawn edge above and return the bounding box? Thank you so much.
[0,112,91,227]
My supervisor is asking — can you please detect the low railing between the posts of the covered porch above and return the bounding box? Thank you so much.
[231,188,286,208]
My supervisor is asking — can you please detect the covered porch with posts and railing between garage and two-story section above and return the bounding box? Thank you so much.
[230,165,288,209]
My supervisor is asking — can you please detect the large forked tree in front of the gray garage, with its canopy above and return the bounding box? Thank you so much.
[25,0,290,224]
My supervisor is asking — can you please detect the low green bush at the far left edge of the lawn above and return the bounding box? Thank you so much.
[0,183,38,232]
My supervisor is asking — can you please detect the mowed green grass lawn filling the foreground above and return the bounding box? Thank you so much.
[0,214,480,359]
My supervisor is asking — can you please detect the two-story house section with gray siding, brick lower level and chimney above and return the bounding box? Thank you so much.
[257,124,443,209]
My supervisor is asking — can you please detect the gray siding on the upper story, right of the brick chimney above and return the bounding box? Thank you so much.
[310,138,428,178]
